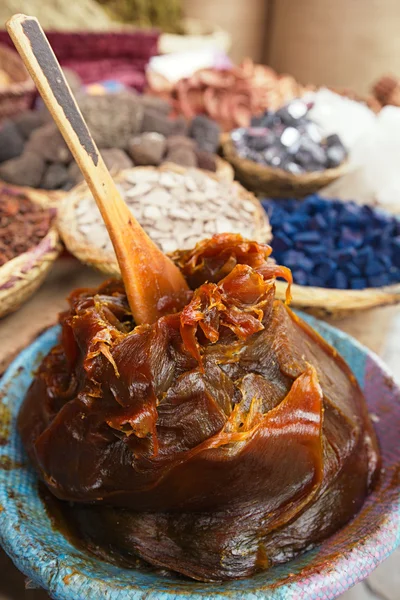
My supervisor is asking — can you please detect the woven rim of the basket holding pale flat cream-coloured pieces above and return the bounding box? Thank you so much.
[58,163,271,275]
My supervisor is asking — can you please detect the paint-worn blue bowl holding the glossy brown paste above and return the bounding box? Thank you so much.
[0,316,400,600]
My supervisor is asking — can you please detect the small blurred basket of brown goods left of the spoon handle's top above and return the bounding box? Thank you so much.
[0,46,35,121]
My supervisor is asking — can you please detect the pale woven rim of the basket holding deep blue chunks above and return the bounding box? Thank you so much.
[276,281,400,317]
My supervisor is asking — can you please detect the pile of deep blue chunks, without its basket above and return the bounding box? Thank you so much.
[262,194,400,290]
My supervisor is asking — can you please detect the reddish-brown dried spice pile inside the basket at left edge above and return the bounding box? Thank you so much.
[0,191,51,266]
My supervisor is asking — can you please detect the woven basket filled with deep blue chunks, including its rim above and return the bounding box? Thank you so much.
[262,194,400,317]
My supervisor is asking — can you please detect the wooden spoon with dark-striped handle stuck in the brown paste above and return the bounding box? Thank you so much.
[6,15,188,325]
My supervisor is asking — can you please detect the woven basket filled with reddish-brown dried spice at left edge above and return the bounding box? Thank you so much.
[0,184,61,317]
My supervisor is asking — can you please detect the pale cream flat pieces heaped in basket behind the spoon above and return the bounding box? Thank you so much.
[66,168,271,254]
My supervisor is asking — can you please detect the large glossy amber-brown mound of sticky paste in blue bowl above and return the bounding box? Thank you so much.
[19,234,380,581]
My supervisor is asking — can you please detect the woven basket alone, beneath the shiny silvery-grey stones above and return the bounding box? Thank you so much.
[221,135,348,198]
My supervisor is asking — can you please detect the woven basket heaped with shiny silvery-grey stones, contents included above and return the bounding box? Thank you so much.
[222,99,348,198]
